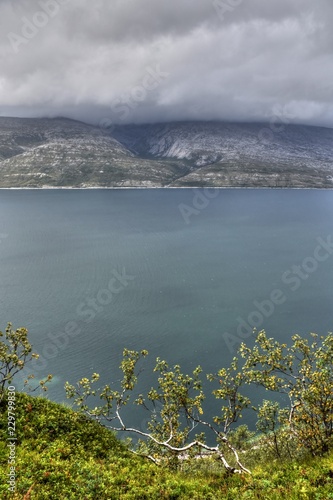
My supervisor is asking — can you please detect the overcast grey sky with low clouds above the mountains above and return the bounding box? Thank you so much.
[0,0,333,127]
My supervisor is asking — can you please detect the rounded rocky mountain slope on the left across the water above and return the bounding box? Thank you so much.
[0,118,184,187]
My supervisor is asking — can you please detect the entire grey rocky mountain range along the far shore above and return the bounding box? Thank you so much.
[0,117,333,188]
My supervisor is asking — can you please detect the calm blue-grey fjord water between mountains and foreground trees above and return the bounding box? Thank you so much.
[0,189,333,426]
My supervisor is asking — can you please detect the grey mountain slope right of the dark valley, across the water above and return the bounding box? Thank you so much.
[112,122,333,187]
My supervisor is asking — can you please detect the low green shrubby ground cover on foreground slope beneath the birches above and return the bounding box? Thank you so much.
[0,393,333,500]
